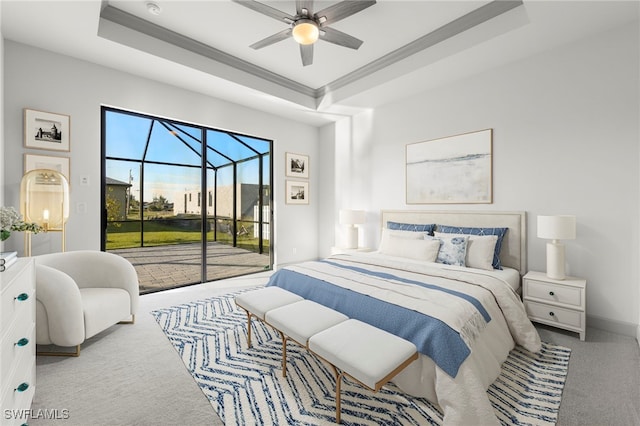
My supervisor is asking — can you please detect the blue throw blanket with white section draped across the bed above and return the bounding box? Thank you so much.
[267,261,491,377]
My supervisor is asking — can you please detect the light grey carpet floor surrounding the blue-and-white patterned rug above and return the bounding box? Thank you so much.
[27,273,640,426]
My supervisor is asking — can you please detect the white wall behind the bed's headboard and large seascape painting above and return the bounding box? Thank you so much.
[321,23,640,336]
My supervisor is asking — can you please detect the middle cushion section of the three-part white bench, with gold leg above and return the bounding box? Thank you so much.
[264,300,349,377]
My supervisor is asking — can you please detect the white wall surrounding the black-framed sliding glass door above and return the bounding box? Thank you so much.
[2,40,319,264]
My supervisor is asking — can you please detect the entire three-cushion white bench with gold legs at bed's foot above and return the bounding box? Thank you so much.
[235,287,418,423]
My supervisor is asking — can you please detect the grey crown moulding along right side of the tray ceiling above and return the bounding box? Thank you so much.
[316,0,523,99]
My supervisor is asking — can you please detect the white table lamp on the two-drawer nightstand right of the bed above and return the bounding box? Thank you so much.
[538,215,576,280]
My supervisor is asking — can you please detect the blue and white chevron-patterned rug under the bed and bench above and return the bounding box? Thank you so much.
[151,290,570,425]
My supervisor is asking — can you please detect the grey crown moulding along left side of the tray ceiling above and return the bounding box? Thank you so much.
[100,5,317,98]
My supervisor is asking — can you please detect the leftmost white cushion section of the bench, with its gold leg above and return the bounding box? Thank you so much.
[235,287,304,347]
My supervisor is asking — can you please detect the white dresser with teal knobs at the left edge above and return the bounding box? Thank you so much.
[0,258,36,425]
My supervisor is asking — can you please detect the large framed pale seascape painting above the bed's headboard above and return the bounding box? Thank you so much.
[405,129,493,204]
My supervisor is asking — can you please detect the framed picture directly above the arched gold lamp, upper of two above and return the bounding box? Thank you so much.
[24,108,71,151]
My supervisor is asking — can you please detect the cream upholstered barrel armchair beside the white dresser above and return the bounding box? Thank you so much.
[34,250,140,356]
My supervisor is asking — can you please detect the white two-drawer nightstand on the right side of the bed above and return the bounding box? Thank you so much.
[522,271,587,340]
